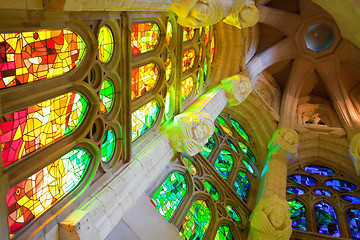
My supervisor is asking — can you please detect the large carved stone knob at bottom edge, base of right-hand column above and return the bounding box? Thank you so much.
[248,196,292,240]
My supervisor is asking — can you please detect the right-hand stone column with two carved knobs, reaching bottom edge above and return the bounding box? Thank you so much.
[248,128,299,240]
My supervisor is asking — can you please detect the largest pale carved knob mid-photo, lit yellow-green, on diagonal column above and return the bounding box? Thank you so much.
[167,112,215,156]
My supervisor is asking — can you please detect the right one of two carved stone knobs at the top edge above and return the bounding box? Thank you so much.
[223,0,260,29]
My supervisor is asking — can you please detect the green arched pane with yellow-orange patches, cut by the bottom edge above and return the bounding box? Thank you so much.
[179,199,211,240]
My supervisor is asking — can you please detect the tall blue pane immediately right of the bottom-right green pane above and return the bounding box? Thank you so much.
[315,201,340,237]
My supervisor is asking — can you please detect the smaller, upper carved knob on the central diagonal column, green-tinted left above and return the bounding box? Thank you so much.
[221,75,252,106]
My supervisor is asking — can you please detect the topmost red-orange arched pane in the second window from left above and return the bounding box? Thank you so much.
[131,22,160,55]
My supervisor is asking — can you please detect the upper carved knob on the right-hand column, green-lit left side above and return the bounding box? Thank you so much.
[268,128,299,161]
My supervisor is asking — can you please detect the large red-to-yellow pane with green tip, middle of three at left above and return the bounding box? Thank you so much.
[0,92,89,167]
